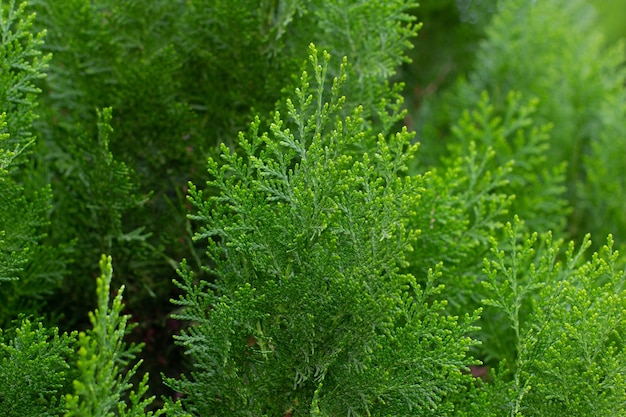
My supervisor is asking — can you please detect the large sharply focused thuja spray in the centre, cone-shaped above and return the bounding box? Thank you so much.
[169,44,475,416]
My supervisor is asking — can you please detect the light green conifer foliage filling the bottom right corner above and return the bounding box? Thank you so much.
[458,219,626,416]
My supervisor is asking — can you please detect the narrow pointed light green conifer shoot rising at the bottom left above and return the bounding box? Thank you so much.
[65,256,161,417]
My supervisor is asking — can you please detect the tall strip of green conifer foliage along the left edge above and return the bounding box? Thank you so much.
[0,1,62,326]
